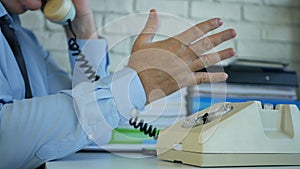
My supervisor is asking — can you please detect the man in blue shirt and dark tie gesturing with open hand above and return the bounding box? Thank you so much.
[0,0,236,168]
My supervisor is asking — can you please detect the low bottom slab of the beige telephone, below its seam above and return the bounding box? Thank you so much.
[160,150,300,167]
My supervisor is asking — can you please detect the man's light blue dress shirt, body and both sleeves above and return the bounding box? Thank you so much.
[0,2,146,169]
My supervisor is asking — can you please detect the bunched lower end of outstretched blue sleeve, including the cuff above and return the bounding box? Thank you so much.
[62,68,146,145]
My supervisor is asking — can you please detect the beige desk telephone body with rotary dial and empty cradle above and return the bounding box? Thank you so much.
[157,101,300,167]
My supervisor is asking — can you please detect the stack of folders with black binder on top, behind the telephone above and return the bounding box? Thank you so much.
[187,64,300,114]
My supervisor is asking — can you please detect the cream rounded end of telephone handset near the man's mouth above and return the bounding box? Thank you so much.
[43,0,76,25]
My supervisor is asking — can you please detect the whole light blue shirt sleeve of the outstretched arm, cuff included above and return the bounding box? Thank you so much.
[0,68,146,168]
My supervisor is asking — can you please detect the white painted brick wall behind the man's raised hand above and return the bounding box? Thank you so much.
[21,0,300,96]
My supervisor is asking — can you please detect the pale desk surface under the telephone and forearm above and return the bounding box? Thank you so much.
[46,152,300,169]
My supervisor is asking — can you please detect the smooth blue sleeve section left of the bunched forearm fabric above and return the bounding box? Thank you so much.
[0,93,91,168]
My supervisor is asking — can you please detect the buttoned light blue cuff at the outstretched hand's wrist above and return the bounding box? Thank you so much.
[111,67,146,118]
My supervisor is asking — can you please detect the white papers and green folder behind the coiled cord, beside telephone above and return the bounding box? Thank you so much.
[110,88,187,144]
